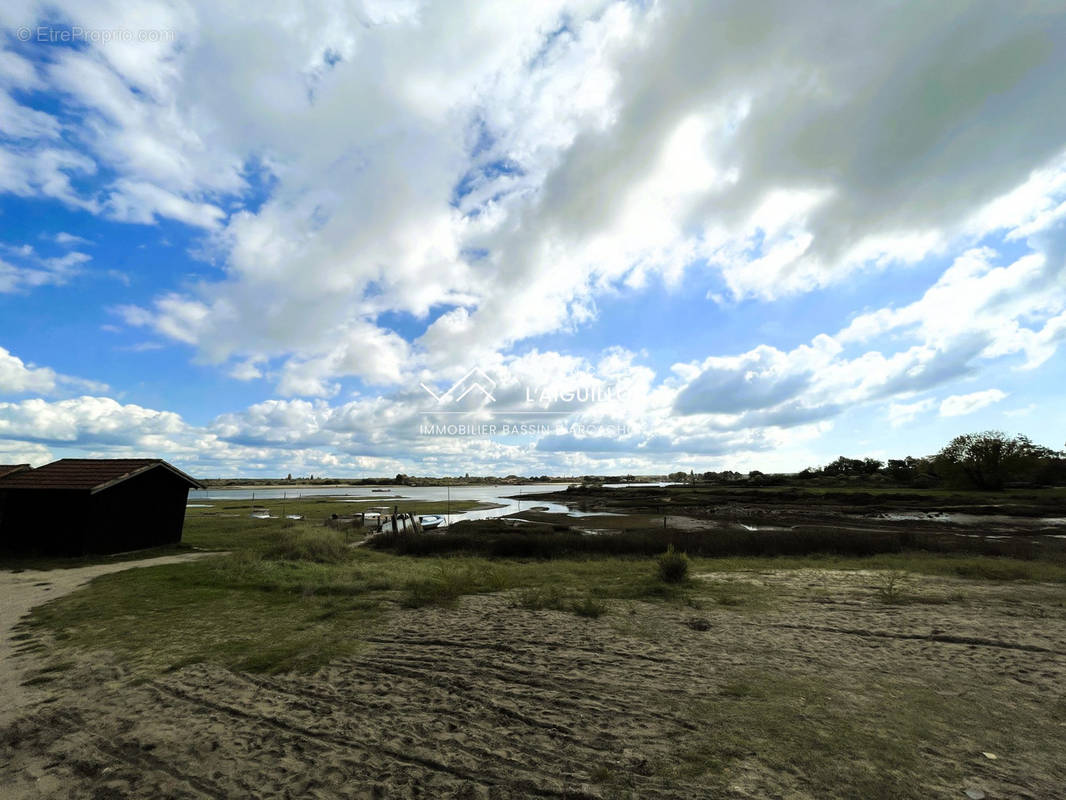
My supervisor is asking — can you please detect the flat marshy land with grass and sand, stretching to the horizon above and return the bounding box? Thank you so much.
[0,467,1066,798]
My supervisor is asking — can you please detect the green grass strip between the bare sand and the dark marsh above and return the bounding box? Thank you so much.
[20,507,1066,674]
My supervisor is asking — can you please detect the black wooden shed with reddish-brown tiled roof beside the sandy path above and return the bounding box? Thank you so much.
[0,459,203,556]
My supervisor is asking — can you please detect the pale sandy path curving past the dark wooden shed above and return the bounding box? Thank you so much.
[0,553,213,726]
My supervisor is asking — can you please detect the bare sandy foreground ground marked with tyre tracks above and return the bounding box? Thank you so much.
[0,571,1066,800]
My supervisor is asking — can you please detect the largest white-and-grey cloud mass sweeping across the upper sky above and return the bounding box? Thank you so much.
[0,0,1048,394]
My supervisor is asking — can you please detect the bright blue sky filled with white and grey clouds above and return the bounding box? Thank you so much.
[0,0,1066,478]
